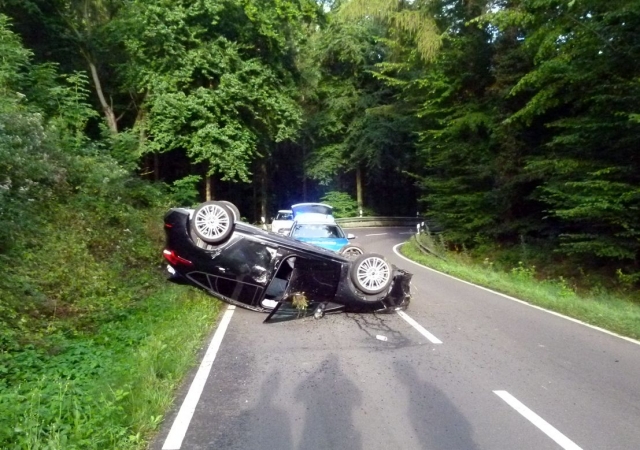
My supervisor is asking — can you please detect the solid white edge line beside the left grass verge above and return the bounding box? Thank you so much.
[162,305,236,450]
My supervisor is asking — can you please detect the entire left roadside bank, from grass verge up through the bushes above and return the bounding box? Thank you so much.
[0,16,219,450]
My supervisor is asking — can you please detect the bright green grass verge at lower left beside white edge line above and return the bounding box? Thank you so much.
[0,285,220,449]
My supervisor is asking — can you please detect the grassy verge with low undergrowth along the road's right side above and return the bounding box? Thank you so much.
[400,232,640,339]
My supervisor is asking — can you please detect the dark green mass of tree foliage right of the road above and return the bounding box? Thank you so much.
[404,0,640,282]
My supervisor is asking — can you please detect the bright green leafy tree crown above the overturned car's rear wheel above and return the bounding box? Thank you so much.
[124,0,310,181]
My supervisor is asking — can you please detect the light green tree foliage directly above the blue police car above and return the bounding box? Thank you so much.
[300,13,415,209]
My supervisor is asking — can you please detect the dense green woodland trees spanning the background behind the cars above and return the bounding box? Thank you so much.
[1,0,640,280]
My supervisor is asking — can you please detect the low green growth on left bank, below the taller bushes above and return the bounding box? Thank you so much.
[0,186,220,450]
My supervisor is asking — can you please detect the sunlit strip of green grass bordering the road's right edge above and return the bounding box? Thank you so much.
[400,235,640,339]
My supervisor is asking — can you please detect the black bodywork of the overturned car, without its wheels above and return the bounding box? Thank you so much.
[164,208,411,312]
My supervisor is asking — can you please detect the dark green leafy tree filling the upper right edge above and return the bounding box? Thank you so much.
[500,1,640,271]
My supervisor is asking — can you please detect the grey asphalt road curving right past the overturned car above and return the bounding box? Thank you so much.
[153,228,640,450]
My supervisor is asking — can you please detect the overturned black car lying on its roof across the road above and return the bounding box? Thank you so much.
[163,201,411,321]
